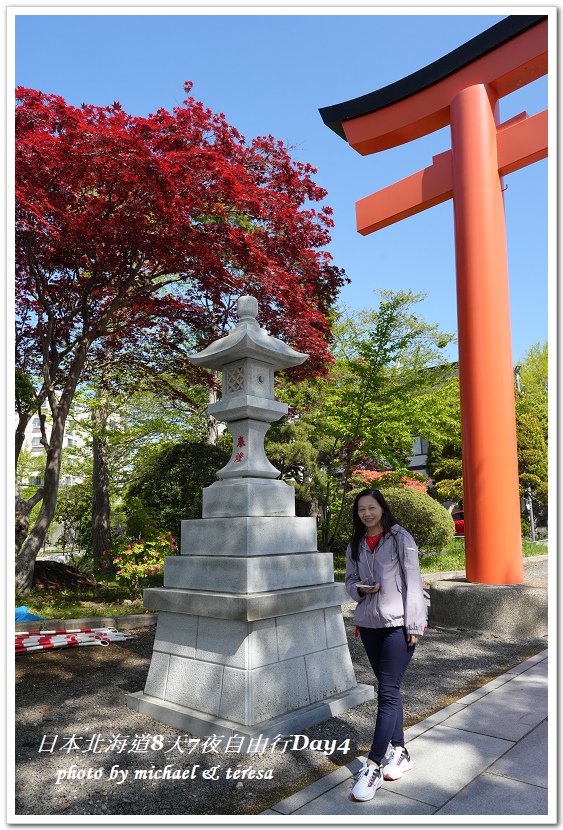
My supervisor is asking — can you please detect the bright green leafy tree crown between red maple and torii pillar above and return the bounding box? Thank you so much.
[318,291,460,469]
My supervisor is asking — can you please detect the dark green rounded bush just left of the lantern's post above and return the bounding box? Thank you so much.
[125,441,229,538]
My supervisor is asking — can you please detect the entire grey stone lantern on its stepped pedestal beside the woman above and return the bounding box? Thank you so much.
[128,297,373,736]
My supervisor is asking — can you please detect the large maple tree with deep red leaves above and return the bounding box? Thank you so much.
[16,83,345,590]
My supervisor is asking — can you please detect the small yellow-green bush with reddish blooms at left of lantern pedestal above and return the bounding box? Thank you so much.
[111,532,177,593]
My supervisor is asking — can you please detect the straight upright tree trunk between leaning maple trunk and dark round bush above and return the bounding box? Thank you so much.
[92,405,112,568]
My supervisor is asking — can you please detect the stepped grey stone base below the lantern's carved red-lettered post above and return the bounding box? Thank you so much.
[127,516,374,737]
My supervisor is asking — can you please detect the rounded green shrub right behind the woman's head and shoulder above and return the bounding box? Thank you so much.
[376,487,455,551]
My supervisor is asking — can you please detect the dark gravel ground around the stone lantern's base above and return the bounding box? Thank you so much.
[15,563,547,818]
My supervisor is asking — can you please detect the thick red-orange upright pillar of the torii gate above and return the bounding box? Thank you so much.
[451,84,523,583]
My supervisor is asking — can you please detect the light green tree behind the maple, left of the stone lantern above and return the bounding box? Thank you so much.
[59,356,214,568]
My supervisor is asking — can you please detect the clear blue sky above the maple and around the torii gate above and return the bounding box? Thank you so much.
[15,7,548,363]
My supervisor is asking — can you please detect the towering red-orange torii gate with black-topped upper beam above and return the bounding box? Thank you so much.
[320,15,548,584]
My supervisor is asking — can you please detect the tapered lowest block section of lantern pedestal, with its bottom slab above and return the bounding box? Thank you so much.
[129,606,373,737]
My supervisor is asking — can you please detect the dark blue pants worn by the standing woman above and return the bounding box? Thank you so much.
[360,626,416,764]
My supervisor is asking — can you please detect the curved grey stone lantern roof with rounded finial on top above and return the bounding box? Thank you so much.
[190,296,309,371]
